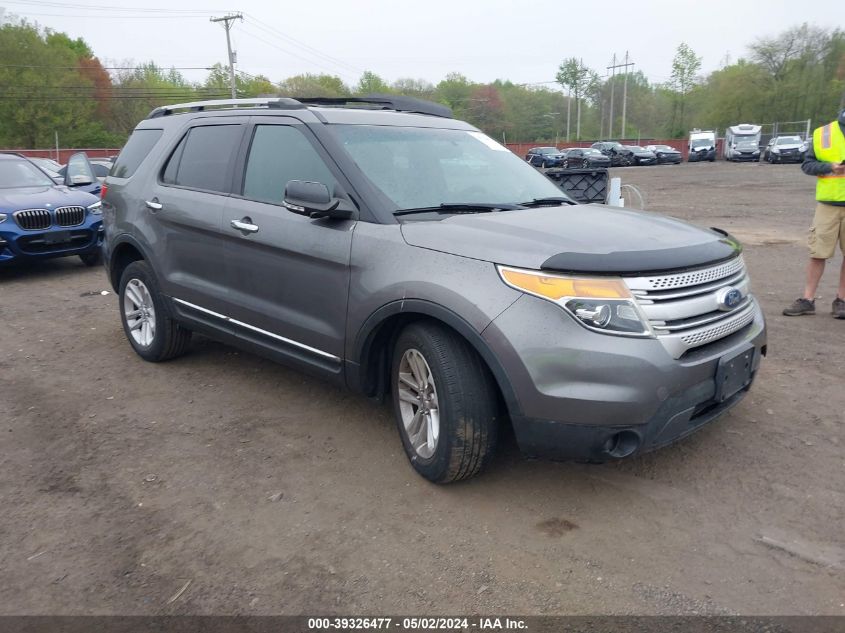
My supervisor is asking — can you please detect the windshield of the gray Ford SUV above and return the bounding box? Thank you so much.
[331,125,565,210]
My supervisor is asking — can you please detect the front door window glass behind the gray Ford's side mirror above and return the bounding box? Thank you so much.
[243,125,336,204]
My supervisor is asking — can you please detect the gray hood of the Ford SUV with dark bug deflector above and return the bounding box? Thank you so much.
[401,204,741,273]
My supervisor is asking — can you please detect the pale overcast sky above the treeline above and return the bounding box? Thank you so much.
[0,0,845,88]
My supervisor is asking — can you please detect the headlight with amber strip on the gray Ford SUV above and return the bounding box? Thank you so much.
[498,266,652,336]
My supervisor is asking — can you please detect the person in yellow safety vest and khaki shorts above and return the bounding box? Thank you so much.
[783,108,845,319]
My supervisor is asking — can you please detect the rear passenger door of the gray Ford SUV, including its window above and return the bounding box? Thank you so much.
[143,117,248,311]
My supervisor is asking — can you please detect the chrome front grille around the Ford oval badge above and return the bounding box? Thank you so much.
[625,257,756,358]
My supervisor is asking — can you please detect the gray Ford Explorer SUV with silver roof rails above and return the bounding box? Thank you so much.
[103,96,766,482]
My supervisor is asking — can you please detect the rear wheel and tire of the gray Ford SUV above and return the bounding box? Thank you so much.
[118,260,191,363]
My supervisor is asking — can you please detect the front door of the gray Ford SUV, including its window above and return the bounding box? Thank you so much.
[219,116,355,375]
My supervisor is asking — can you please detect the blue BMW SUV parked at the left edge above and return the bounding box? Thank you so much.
[0,153,103,266]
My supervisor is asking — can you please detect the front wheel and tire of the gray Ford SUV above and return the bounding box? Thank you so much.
[391,322,498,483]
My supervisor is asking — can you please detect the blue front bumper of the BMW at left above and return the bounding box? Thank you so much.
[0,214,103,264]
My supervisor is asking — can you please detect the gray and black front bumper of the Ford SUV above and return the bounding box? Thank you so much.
[483,296,766,461]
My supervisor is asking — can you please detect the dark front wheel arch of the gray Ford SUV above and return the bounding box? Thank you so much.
[347,299,521,416]
